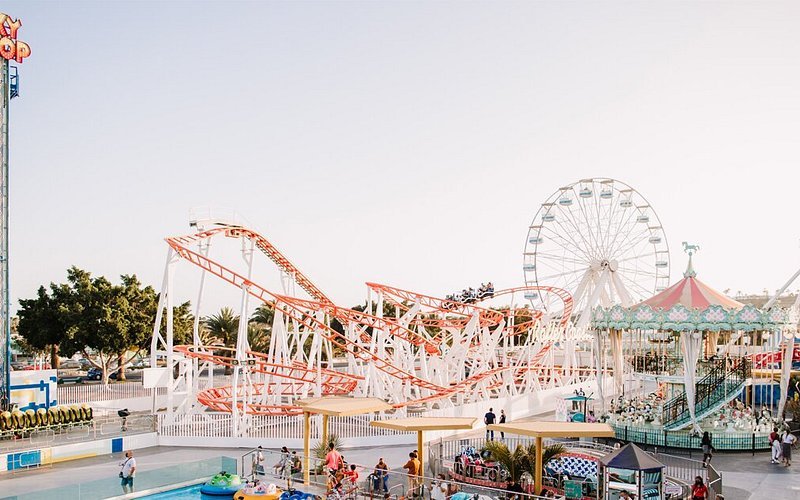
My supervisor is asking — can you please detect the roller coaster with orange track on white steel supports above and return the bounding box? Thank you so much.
[151,221,582,415]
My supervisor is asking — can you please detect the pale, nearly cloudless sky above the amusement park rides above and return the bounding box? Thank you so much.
[2,0,800,313]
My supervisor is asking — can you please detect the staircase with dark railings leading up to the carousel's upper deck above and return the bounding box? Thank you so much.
[661,358,751,431]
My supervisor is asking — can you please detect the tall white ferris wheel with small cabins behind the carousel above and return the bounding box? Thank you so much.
[523,178,670,327]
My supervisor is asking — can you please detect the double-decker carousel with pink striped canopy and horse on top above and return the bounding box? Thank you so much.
[592,244,796,449]
